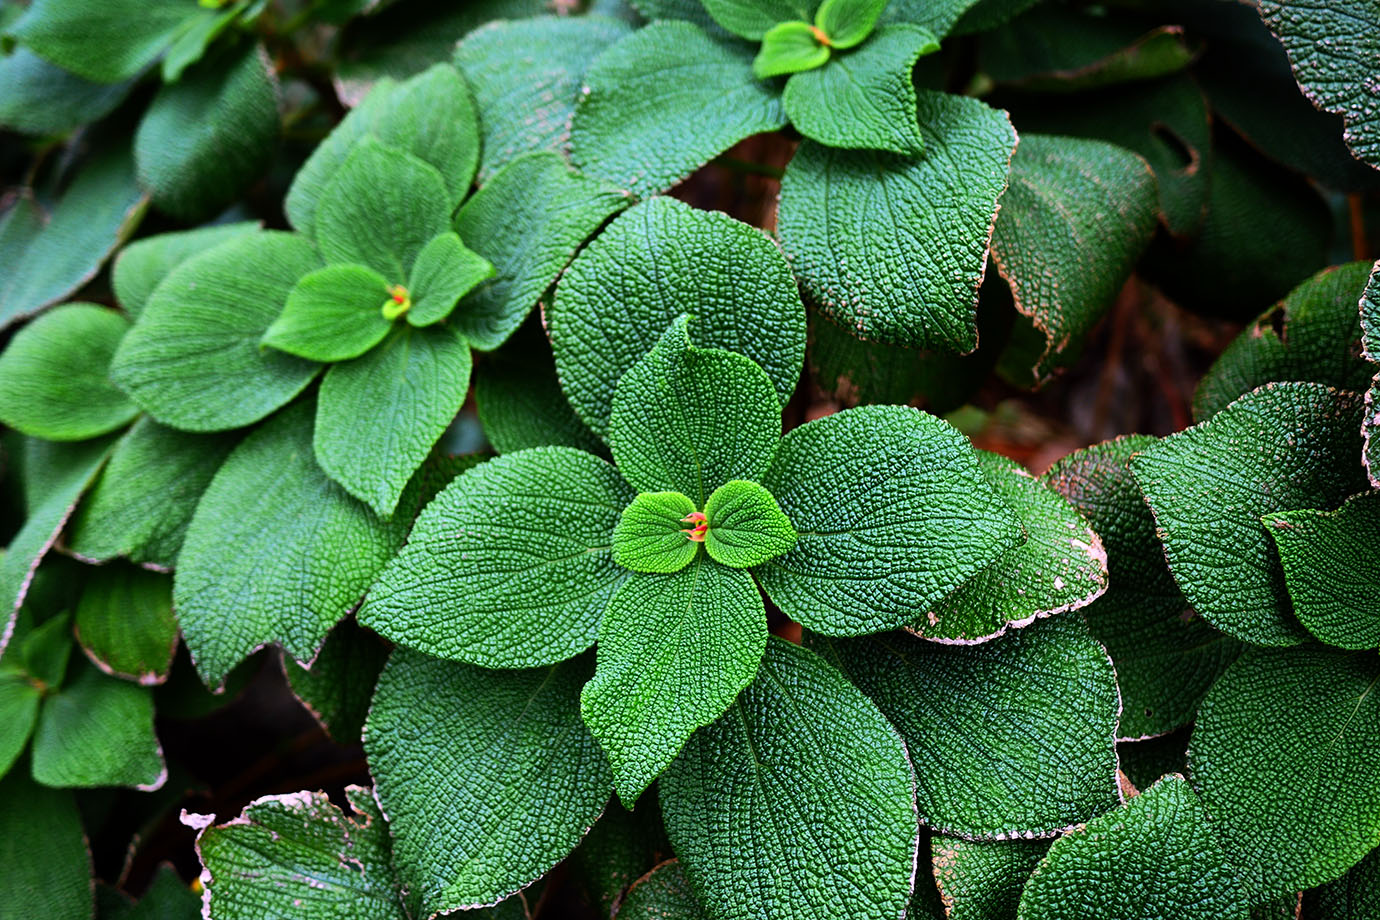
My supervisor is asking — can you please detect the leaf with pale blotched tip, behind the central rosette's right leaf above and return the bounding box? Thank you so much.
[907,451,1107,643]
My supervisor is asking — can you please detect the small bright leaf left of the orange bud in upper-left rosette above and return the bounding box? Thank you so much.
[261,263,395,361]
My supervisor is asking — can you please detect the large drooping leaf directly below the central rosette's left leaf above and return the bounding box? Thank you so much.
[364,648,611,917]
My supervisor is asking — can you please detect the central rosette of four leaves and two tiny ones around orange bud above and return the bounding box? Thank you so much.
[359,316,1021,803]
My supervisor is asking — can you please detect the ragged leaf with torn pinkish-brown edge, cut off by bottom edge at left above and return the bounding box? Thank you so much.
[194,786,410,920]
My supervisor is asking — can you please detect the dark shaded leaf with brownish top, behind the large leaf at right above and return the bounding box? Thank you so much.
[1043,434,1242,739]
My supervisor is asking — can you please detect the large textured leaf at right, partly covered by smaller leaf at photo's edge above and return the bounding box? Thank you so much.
[1130,383,1366,646]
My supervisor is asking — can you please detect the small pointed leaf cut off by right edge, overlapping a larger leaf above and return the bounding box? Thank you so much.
[1261,492,1380,648]
